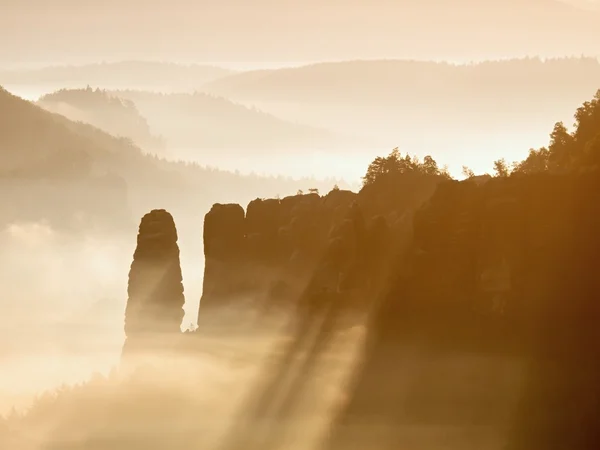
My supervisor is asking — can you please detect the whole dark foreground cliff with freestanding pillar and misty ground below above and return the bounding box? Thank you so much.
[0,91,600,450]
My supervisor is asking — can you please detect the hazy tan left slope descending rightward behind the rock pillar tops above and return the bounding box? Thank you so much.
[0,89,343,236]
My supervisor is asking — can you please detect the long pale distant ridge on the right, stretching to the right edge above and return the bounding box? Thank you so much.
[203,58,600,109]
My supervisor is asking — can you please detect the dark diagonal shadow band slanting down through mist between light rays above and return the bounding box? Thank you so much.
[216,203,376,449]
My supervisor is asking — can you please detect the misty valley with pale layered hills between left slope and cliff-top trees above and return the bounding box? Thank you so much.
[0,57,600,179]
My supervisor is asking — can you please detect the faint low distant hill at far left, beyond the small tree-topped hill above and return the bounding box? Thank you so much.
[0,61,234,92]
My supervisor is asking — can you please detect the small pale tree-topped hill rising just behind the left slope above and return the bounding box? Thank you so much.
[37,87,164,152]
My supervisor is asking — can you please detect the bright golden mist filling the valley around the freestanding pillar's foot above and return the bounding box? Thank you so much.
[0,211,372,450]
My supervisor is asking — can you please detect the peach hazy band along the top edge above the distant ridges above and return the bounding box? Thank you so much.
[0,0,600,62]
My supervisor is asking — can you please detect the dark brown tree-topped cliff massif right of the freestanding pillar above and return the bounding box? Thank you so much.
[118,91,600,450]
